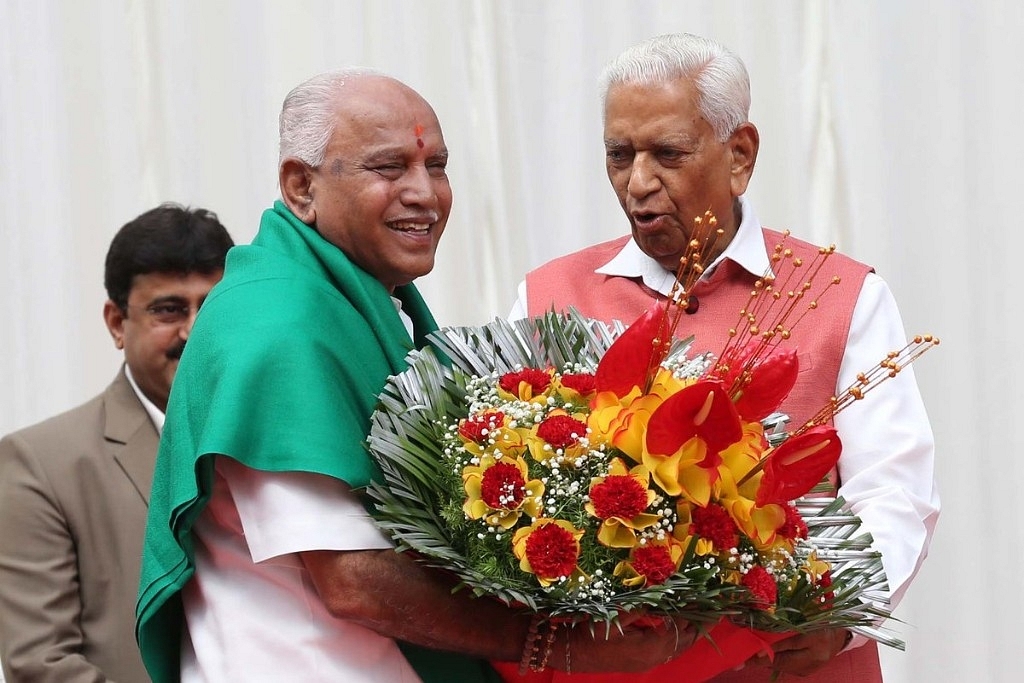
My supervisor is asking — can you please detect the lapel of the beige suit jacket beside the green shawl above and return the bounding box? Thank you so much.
[103,367,160,505]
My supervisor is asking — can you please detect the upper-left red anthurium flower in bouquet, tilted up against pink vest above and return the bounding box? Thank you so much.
[594,305,672,396]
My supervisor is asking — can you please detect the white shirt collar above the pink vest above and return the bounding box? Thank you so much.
[595,196,770,296]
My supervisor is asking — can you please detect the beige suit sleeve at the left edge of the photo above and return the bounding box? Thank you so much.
[0,434,109,683]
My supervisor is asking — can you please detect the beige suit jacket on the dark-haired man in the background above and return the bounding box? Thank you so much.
[0,368,159,683]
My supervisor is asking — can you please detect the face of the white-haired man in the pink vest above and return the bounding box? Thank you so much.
[604,78,758,271]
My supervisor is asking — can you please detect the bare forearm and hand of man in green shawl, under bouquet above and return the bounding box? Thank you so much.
[300,550,696,673]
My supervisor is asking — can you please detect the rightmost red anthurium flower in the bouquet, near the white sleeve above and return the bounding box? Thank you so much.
[757,428,843,506]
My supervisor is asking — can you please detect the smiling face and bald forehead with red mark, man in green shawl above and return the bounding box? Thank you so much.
[282,77,452,291]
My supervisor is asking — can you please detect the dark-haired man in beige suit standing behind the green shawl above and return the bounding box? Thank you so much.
[0,205,232,683]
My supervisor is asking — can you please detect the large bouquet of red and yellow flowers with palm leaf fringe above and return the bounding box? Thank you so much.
[369,216,938,681]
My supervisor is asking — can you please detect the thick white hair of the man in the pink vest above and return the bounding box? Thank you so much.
[599,33,751,141]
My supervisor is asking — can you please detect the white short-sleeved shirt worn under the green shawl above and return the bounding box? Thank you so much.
[181,457,420,683]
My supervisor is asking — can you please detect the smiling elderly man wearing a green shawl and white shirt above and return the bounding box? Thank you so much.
[137,70,689,683]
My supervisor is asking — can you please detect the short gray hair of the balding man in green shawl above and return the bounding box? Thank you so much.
[278,67,387,168]
